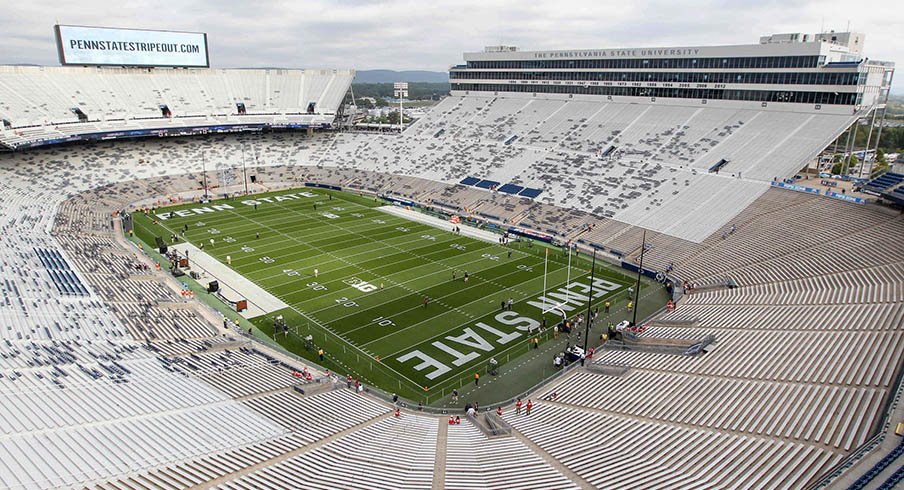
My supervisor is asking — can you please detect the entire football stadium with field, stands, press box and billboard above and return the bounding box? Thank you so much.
[0,14,904,490]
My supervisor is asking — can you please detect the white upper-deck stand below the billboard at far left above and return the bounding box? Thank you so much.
[0,66,354,148]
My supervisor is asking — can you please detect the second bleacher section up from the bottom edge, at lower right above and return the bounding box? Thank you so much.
[549,369,885,451]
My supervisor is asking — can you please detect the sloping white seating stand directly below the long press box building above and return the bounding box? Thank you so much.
[318,96,853,242]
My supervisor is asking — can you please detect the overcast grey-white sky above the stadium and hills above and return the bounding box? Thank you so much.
[0,0,904,91]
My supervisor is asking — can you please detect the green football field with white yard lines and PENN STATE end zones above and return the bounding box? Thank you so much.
[135,188,652,402]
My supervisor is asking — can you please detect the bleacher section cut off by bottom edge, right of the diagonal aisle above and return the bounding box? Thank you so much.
[505,402,840,489]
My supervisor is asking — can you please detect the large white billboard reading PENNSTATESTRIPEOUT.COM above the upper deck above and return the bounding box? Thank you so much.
[54,25,210,68]
